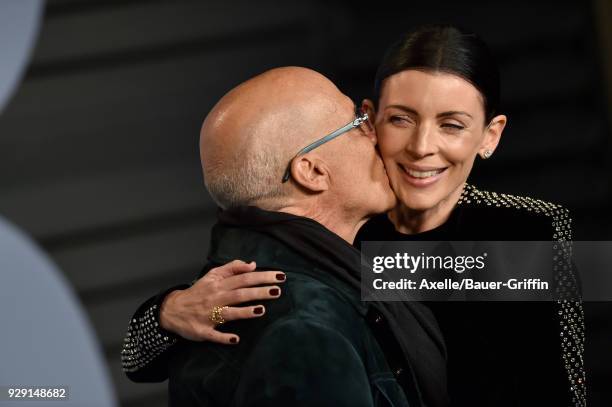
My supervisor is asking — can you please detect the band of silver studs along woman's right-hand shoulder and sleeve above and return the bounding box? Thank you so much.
[457,185,586,407]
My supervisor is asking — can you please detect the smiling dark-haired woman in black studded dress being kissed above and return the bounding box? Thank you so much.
[122,26,585,405]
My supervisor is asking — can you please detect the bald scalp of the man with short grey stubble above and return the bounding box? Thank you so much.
[200,67,350,208]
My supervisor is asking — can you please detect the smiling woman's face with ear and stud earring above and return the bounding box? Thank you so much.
[375,70,506,211]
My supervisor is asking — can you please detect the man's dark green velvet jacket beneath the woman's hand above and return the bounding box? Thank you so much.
[168,208,419,407]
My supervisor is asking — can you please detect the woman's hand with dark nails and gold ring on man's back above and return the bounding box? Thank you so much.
[159,260,285,344]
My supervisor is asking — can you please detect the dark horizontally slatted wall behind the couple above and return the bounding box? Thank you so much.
[0,0,612,406]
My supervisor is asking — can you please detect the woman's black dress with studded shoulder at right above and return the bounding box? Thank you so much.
[356,185,586,406]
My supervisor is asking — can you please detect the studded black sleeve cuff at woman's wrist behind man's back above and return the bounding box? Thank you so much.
[121,284,189,382]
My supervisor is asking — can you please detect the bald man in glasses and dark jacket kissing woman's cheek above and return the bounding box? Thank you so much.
[123,67,418,407]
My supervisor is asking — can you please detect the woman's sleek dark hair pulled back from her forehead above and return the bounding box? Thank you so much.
[374,25,500,124]
